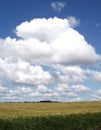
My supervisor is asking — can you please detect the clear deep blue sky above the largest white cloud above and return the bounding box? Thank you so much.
[0,0,101,52]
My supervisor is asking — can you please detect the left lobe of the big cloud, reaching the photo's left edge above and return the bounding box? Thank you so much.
[0,37,52,63]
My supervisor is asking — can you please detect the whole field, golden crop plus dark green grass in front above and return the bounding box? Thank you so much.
[0,101,101,130]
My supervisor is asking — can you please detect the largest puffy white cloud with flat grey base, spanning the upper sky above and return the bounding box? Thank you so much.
[0,17,98,65]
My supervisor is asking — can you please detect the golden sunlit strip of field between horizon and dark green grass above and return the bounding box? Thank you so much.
[0,101,101,118]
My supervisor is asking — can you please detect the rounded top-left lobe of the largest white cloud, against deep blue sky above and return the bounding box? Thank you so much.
[16,17,70,43]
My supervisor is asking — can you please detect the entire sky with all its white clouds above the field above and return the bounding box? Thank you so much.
[0,0,101,102]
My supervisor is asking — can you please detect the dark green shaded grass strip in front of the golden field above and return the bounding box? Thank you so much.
[0,113,101,130]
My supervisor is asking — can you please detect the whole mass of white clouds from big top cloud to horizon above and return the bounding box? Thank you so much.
[0,16,101,101]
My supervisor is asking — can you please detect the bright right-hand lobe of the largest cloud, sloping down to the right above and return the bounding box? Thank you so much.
[51,28,100,65]
